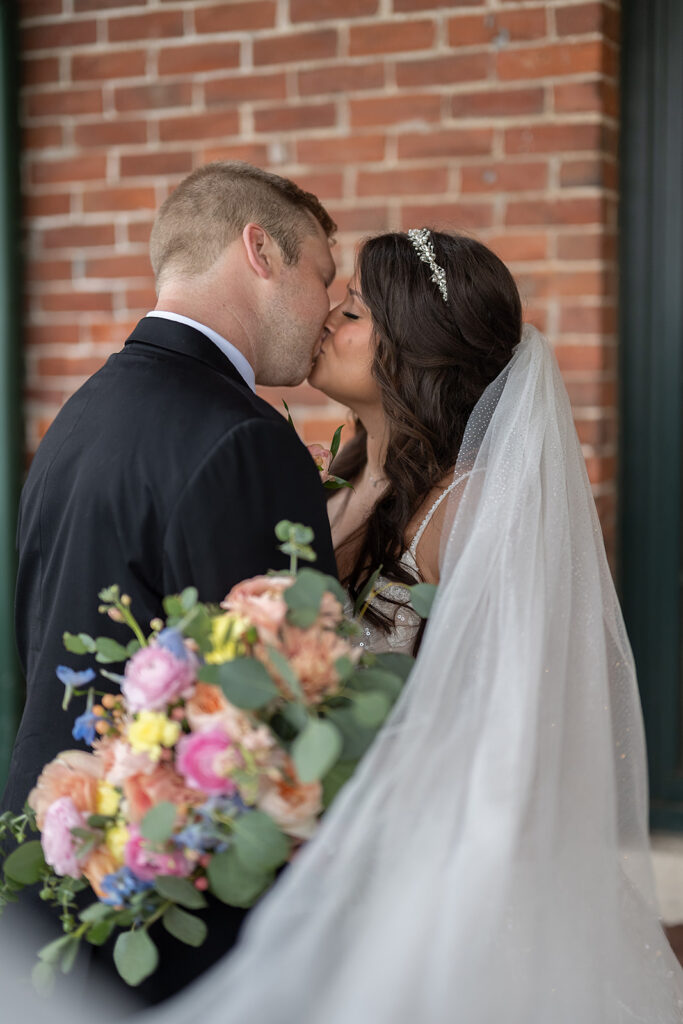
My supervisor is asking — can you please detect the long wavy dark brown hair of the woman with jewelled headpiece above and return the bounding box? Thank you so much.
[332,231,522,632]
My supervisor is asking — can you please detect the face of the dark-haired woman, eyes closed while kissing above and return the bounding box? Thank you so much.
[308,279,380,409]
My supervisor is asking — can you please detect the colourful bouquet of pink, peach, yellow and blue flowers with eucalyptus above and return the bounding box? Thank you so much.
[0,521,431,989]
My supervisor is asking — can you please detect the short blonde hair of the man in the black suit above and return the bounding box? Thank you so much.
[150,161,337,288]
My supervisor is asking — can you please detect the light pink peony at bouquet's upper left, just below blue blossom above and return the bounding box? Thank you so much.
[121,644,197,712]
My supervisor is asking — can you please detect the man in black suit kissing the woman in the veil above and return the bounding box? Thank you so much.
[3,163,336,1002]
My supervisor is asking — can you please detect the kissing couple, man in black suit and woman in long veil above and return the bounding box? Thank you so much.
[4,163,683,1024]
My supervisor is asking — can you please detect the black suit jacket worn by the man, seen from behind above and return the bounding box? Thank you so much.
[3,317,336,1000]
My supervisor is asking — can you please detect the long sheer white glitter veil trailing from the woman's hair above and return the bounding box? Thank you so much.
[144,327,683,1024]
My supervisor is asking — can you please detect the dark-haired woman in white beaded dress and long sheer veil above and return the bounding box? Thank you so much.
[145,229,683,1024]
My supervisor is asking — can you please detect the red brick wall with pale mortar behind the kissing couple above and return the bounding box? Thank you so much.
[18,0,618,547]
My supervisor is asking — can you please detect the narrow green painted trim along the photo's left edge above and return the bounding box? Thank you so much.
[0,3,24,792]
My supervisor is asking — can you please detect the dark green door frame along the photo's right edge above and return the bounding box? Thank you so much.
[620,0,683,829]
